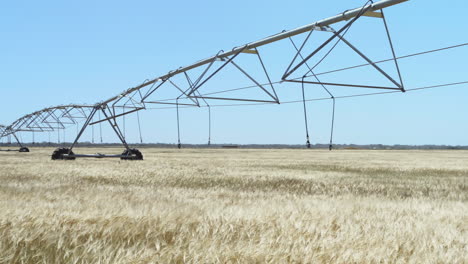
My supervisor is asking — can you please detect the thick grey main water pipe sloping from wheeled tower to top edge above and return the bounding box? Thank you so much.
[102,0,409,104]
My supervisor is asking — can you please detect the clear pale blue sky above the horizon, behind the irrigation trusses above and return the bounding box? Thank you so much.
[0,0,468,145]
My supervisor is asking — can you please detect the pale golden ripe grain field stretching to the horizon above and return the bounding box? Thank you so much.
[0,148,468,263]
